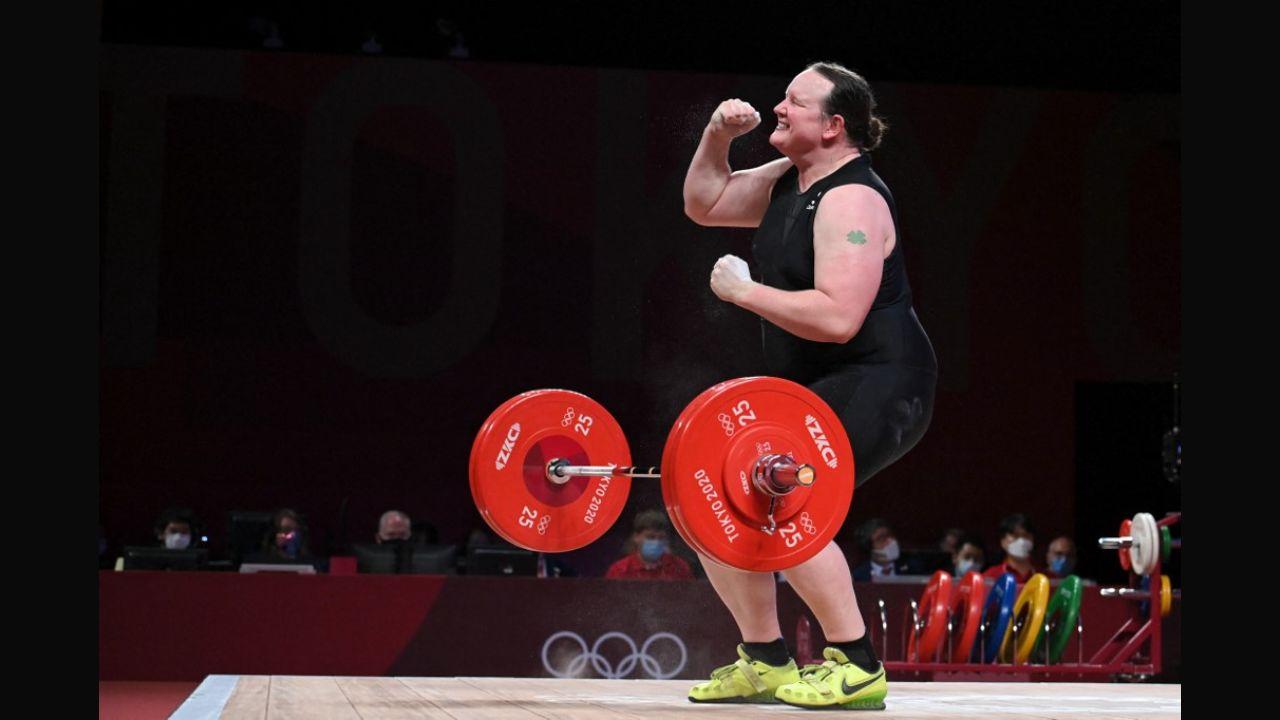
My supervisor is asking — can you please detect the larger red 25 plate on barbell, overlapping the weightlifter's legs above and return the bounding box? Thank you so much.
[662,377,854,571]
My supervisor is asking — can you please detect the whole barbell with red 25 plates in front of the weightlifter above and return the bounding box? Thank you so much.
[470,377,854,571]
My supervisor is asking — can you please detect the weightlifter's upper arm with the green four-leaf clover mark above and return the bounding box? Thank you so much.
[813,184,893,340]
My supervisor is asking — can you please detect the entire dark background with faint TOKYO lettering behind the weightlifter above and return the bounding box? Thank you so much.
[100,3,1181,584]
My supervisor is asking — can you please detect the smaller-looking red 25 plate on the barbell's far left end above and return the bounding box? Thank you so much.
[471,389,631,552]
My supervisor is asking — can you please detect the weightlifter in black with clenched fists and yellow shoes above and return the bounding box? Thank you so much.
[684,63,937,710]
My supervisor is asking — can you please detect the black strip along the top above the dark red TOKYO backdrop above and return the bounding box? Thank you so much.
[102,0,1181,92]
